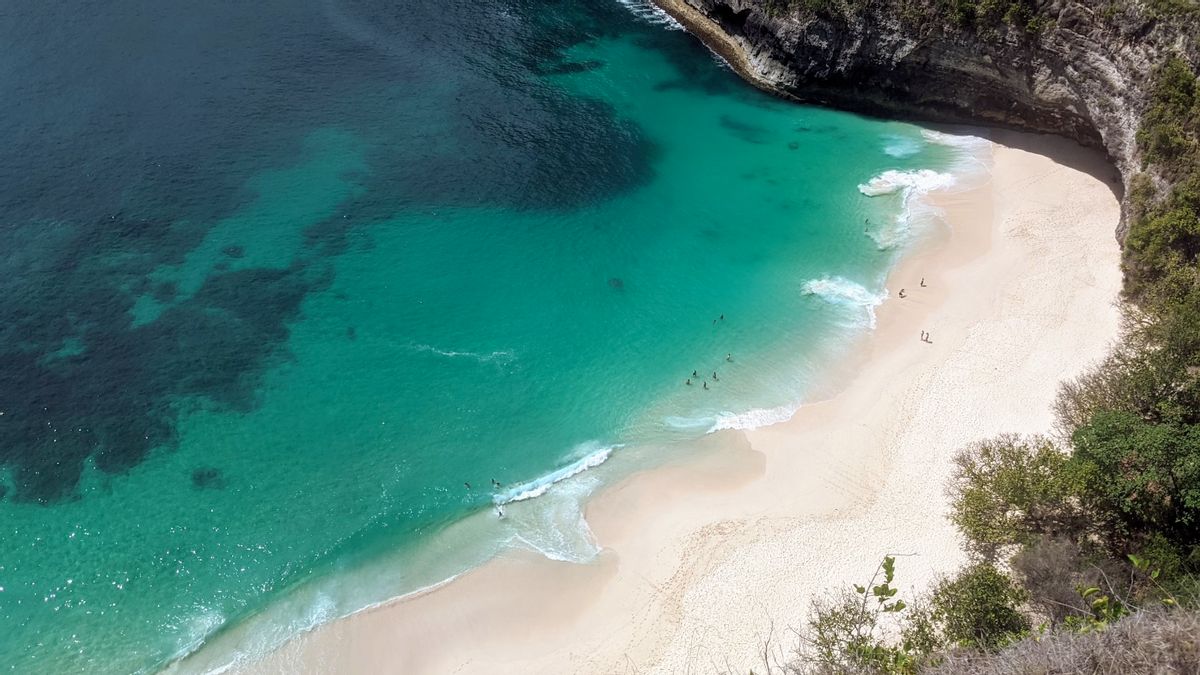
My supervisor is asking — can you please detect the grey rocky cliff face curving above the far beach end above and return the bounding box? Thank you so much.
[659,0,1198,234]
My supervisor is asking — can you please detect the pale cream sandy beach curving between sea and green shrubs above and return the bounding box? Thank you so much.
[223,127,1121,674]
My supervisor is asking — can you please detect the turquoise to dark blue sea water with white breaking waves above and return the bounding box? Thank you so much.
[0,1,956,673]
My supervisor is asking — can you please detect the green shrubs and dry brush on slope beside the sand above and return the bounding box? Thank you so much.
[772,43,1200,674]
